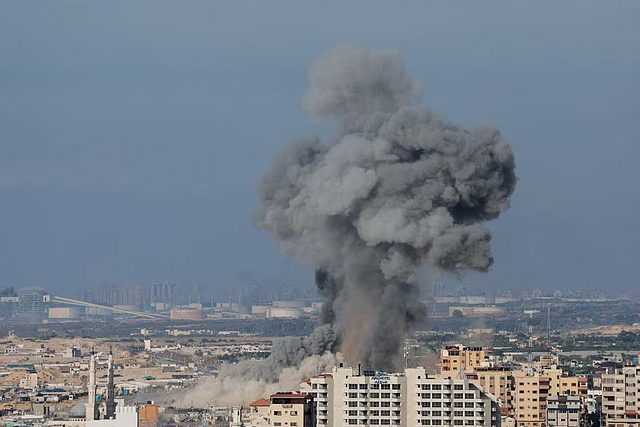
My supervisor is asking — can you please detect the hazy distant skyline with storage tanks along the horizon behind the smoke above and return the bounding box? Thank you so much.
[0,282,640,323]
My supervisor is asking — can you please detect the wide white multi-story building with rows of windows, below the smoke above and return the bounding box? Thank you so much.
[300,367,501,427]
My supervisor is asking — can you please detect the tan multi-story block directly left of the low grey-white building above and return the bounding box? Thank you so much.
[512,371,549,427]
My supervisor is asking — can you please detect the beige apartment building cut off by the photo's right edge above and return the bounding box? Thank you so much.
[602,366,640,427]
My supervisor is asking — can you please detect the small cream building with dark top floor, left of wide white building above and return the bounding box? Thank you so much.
[268,392,316,427]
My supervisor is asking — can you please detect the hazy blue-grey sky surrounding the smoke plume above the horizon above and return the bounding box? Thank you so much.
[0,0,640,295]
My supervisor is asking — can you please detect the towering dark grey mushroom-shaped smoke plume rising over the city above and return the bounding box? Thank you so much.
[257,46,516,368]
